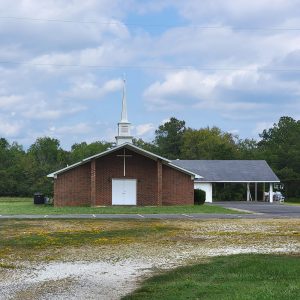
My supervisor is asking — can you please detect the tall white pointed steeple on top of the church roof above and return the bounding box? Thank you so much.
[116,78,132,146]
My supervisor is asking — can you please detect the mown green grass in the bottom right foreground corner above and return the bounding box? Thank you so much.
[122,255,300,300]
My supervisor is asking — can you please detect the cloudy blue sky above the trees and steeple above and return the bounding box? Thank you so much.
[0,0,300,149]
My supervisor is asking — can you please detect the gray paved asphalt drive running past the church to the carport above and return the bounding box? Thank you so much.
[0,201,300,219]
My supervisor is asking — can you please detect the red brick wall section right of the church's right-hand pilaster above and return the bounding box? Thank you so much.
[162,165,194,205]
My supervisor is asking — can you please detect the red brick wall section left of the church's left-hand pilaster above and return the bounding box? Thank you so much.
[54,163,91,206]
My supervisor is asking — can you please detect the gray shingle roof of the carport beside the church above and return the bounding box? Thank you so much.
[172,160,279,182]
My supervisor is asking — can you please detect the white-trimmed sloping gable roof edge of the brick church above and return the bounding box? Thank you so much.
[47,143,201,178]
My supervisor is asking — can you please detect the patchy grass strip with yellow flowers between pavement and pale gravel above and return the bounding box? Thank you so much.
[0,220,175,253]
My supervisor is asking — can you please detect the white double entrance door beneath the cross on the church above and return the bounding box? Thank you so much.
[112,179,136,205]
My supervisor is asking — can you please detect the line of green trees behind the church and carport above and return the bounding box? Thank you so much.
[0,117,300,197]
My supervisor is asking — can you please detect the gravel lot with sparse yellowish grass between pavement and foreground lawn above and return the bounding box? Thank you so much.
[0,219,300,300]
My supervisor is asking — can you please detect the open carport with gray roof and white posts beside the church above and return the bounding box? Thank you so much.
[173,160,280,202]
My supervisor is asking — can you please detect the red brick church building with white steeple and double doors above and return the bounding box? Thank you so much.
[48,84,197,206]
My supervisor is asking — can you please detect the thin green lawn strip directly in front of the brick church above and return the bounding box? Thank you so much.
[0,197,241,215]
